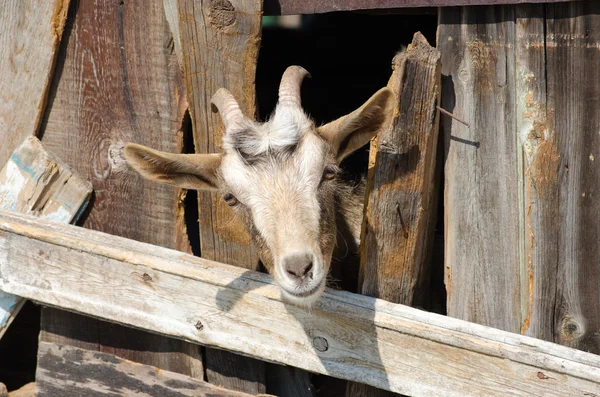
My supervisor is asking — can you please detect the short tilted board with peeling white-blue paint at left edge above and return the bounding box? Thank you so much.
[0,137,92,338]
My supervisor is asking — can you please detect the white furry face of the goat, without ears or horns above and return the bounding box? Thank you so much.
[221,107,329,303]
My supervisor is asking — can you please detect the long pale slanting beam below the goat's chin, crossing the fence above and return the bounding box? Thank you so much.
[0,212,600,397]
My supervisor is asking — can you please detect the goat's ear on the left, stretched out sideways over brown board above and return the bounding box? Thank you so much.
[123,143,221,191]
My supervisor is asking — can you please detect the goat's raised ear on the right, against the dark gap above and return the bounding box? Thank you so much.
[317,88,395,164]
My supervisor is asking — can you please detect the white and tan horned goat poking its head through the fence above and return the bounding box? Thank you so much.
[124,66,395,306]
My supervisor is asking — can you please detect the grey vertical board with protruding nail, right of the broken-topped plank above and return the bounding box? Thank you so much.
[438,6,521,332]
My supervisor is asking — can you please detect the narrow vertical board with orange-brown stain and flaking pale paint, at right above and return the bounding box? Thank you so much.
[515,5,560,341]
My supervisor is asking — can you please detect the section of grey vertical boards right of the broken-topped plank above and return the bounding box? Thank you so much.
[438,2,600,353]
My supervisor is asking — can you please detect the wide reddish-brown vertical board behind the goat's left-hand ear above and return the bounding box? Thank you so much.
[41,0,203,377]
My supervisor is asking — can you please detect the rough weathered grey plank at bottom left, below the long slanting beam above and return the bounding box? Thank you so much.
[35,342,260,397]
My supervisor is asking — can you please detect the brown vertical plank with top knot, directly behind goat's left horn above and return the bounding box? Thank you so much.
[177,0,266,393]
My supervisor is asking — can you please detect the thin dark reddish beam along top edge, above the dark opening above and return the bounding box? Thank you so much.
[263,0,581,15]
